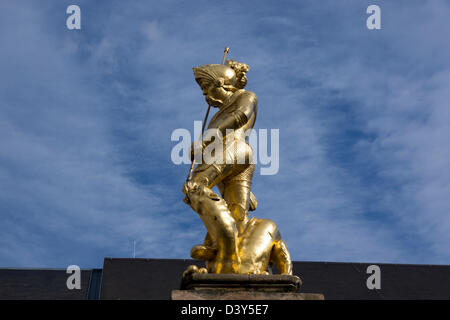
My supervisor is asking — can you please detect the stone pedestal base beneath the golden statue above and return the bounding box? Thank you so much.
[171,273,324,300]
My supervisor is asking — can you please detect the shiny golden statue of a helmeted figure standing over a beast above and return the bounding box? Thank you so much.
[183,48,292,275]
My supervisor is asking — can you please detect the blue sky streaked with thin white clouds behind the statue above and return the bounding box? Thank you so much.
[0,0,450,268]
